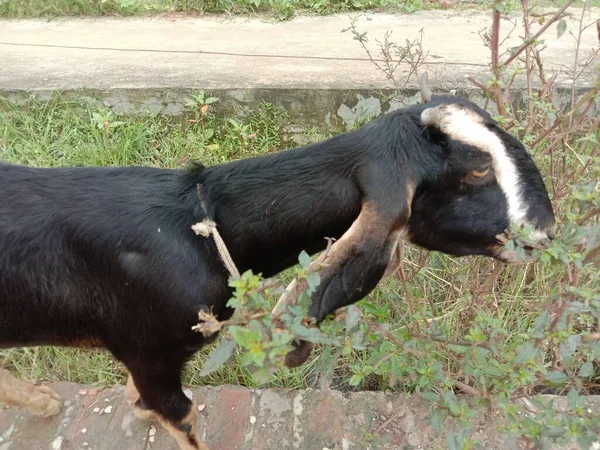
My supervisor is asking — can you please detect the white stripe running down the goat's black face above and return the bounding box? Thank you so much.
[421,105,527,225]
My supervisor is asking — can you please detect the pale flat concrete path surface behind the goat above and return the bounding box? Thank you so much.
[0,8,600,93]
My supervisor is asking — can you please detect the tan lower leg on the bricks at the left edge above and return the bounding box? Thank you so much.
[0,368,62,417]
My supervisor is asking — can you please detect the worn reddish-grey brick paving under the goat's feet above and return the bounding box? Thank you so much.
[0,383,600,450]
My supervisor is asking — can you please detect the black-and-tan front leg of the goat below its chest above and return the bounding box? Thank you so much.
[125,357,209,450]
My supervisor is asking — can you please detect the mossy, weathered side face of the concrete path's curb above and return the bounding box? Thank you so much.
[0,88,600,135]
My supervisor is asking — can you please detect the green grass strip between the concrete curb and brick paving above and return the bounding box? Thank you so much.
[0,95,600,396]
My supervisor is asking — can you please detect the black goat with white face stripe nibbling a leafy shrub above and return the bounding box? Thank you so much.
[0,93,555,450]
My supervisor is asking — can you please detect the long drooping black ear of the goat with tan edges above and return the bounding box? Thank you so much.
[273,178,414,367]
